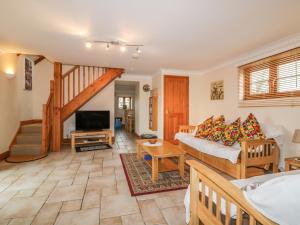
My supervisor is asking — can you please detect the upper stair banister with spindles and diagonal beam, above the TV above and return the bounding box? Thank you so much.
[62,66,124,121]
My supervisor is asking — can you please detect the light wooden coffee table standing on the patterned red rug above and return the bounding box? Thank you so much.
[136,139,185,183]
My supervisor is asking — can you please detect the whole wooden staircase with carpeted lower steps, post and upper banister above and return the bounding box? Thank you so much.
[6,62,124,162]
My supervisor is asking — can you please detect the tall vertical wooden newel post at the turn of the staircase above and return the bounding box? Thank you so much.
[52,62,62,152]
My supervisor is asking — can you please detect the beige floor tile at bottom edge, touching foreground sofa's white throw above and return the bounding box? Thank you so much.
[162,206,186,225]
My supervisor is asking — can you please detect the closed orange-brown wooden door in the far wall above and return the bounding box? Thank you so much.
[164,75,189,142]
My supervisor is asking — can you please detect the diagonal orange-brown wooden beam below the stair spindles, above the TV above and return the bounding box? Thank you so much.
[62,68,124,121]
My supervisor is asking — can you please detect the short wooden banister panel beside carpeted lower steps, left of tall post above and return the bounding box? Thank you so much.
[42,80,54,154]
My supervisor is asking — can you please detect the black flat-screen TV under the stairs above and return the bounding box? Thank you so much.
[76,111,110,131]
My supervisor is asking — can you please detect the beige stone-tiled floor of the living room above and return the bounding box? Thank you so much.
[0,131,185,225]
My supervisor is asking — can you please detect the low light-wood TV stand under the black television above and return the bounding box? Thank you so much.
[71,130,112,152]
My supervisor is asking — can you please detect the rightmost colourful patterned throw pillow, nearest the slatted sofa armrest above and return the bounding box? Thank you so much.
[239,113,266,142]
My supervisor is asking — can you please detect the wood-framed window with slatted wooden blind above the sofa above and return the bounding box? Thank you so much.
[238,47,300,107]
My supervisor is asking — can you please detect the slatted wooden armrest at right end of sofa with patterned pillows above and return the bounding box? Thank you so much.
[241,139,279,178]
